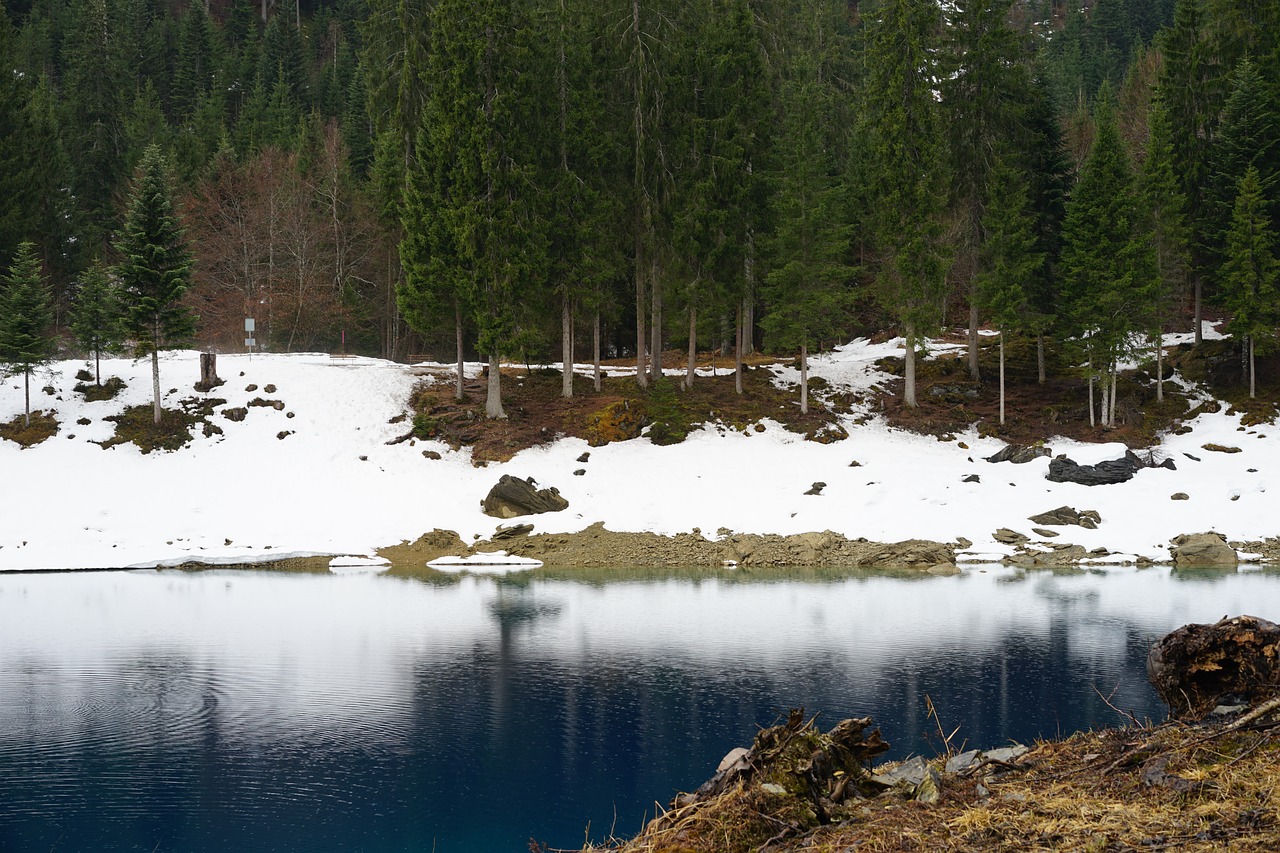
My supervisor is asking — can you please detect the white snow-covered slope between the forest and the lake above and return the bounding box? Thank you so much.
[0,326,1280,570]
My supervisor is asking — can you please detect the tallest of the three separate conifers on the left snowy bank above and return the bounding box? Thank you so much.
[115,146,195,424]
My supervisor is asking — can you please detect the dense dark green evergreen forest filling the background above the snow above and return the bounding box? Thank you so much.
[0,0,1280,414]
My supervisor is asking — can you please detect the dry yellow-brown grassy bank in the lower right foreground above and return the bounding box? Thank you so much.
[576,701,1280,853]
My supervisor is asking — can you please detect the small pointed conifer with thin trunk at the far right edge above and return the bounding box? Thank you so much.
[1221,167,1280,400]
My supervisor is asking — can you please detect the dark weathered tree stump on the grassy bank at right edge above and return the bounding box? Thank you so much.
[1147,616,1280,720]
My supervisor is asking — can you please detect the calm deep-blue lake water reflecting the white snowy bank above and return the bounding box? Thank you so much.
[0,558,1280,853]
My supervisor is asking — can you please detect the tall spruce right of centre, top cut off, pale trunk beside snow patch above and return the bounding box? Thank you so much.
[863,0,950,407]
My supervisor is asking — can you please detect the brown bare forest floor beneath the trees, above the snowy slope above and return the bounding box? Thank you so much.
[412,333,1280,465]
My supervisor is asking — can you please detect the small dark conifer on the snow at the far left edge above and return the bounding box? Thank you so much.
[0,241,56,427]
